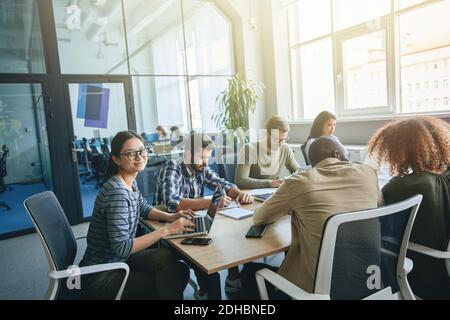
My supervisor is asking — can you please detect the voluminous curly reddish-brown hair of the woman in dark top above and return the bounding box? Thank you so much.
[368,116,450,176]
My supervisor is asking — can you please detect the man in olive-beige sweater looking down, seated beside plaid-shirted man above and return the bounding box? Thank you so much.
[235,116,300,189]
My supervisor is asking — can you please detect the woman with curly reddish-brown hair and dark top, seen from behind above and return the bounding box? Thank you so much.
[369,116,450,299]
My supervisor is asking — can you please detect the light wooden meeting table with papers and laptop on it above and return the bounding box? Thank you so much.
[141,192,291,300]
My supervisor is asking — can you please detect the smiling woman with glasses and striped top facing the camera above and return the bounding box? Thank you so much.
[80,131,193,299]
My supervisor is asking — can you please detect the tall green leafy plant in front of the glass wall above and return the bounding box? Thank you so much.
[212,74,265,152]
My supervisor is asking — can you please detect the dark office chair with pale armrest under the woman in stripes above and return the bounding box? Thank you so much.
[24,191,130,300]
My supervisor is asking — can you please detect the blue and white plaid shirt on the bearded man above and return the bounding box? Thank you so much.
[153,160,236,212]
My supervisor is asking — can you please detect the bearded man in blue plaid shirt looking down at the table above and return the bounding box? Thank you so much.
[153,133,253,299]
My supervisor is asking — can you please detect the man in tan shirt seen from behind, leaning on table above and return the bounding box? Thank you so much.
[241,137,382,299]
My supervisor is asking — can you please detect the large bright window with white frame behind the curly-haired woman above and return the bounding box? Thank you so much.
[288,0,450,120]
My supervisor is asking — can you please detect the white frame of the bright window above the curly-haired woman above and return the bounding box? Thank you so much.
[284,0,450,123]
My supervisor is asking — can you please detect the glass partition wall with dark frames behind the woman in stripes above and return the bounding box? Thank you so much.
[0,0,234,237]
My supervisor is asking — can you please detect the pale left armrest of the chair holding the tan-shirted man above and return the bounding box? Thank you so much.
[256,268,330,300]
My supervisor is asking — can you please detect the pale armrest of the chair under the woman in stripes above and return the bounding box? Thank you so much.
[48,262,130,300]
